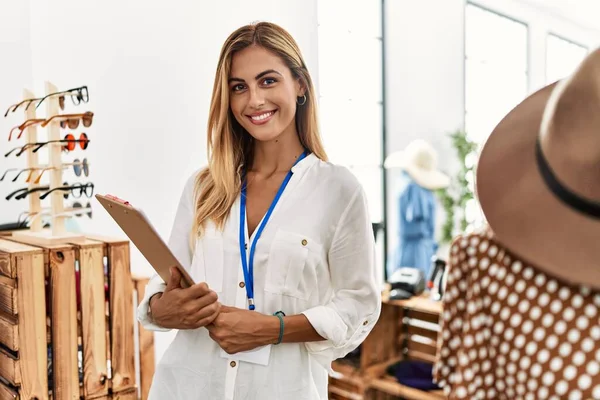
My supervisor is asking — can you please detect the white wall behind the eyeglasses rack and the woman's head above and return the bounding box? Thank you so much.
[0,0,318,366]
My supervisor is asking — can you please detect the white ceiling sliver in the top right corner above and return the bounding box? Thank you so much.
[522,0,600,30]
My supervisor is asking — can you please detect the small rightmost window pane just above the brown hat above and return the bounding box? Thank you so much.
[546,33,588,84]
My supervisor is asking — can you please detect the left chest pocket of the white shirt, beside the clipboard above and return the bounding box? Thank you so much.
[192,227,224,293]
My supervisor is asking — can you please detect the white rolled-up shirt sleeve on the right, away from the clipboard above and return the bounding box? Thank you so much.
[303,186,381,370]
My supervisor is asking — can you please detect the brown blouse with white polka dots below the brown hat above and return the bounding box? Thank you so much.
[434,232,600,400]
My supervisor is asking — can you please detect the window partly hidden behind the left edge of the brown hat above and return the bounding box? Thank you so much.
[465,3,528,229]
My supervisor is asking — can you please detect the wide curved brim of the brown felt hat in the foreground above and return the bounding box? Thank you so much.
[476,84,600,288]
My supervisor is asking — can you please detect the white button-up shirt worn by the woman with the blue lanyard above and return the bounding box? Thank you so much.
[137,154,381,400]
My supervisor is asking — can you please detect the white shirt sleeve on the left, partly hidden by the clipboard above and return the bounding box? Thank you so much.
[137,172,197,332]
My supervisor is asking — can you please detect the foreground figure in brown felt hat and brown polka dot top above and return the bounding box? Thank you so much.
[436,46,600,400]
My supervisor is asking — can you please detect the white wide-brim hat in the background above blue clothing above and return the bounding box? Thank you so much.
[384,139,450,190]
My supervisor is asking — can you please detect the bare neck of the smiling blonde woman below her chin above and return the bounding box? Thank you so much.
[251,129,304,176]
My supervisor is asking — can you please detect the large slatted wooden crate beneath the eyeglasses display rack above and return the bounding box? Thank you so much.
[0,236,146,400]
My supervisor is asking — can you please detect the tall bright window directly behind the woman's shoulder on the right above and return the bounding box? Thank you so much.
[318,0,383,222]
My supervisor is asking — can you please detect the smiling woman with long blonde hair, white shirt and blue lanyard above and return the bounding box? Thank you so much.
[138,23,380,400]
